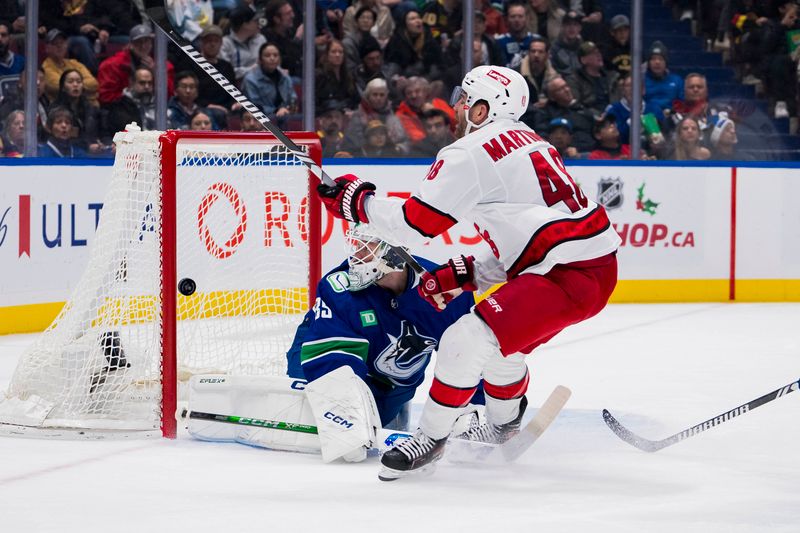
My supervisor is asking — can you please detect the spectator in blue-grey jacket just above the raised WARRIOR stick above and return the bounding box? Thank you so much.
[243,43,297,128]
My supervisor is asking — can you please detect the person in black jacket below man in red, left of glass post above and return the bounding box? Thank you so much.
[104,66,156,140]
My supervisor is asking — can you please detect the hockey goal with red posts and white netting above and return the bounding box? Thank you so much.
[0,131,321,437]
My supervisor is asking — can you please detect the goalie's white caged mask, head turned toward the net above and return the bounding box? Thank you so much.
[345,224,406,291]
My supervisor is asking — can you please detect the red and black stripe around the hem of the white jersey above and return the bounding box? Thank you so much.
[508,206,611,279]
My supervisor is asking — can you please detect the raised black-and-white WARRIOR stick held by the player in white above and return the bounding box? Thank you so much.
[144,0,425,275]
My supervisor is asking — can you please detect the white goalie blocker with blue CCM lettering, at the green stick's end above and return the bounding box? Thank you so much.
[306,366,381,463]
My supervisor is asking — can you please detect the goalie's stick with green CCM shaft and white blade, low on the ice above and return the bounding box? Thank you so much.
[188,385,572,464]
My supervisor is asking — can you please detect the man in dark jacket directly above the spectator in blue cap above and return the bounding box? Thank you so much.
[533,77,594,152]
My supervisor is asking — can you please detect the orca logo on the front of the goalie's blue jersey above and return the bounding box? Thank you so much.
[375,320,436,385]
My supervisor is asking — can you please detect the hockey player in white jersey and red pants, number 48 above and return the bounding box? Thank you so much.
[318,66,620,480]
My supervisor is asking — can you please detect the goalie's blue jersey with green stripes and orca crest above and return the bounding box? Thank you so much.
[287,256,475,425]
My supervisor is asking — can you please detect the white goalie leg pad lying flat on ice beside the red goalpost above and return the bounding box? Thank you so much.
[187,374,320,453]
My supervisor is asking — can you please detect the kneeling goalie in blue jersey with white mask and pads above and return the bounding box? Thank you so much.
[188,224,483,462]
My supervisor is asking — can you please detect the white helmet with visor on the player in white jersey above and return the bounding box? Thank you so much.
[450,65,530,132]
